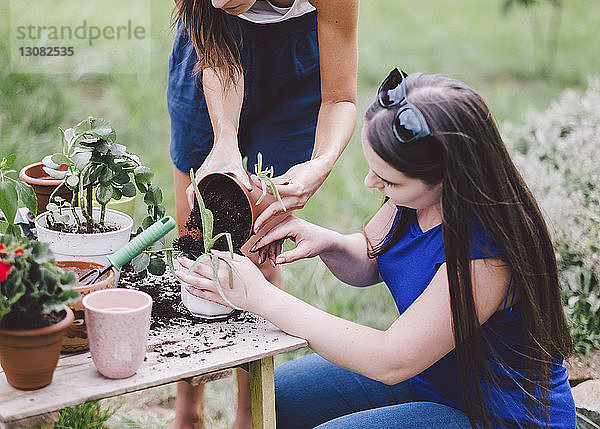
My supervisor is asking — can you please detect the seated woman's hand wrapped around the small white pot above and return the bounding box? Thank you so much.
[175,250,275,311]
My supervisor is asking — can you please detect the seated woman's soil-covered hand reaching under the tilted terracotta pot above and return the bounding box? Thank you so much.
[250,215,335,265]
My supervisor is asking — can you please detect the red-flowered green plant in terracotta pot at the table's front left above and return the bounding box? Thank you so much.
[0,234,79,389]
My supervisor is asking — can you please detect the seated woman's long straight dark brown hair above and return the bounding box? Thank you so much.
[366,74,572,427]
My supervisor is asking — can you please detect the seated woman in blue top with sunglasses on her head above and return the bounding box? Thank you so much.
[178,69,576,429]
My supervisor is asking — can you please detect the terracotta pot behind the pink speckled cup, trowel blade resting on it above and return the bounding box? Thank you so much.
[56,261,115,353]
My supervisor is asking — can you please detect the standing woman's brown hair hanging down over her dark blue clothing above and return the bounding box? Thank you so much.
[172,0,242,84]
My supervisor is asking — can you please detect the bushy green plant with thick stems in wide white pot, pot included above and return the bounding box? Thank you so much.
[36,117,165,263]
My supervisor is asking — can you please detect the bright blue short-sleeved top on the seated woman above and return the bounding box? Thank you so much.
[377,210,576,429]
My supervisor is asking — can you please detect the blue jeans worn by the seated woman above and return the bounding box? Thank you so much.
[275,354,471,429]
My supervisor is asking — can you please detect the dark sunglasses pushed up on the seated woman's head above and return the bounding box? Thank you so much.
[377,68,431,143]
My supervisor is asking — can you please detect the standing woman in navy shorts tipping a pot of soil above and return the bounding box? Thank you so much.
[167,0,358,428]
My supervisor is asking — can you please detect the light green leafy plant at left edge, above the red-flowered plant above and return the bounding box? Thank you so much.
[0,154,37,237]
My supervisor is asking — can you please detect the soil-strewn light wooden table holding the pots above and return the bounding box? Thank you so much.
[0,313,307,429]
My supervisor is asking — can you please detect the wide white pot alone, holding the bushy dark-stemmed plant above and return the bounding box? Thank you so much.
[35,208,133,265]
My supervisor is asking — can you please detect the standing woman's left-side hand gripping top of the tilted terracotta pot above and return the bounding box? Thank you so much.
[185,137,252,208]
